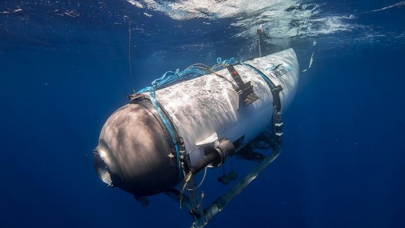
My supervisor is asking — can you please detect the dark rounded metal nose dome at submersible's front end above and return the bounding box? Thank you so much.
[94,101,180,196]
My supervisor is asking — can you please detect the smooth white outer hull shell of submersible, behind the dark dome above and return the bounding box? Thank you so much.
[156,49,299,168]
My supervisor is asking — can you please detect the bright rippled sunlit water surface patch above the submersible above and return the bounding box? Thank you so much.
[127,0,405,50]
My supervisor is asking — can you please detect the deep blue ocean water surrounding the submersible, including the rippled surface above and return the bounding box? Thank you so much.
[0,0,405,228]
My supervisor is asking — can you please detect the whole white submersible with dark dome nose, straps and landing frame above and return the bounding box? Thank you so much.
[94,49,299,227]
